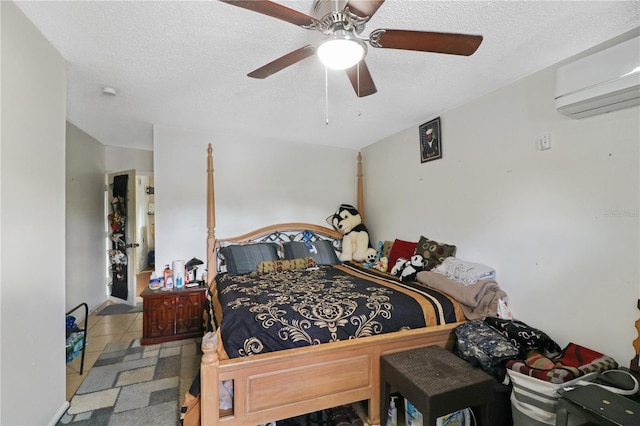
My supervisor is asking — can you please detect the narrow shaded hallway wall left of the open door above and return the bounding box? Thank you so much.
[65,123,107,312]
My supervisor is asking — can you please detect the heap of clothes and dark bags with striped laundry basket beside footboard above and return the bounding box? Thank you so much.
[455,317,620,426]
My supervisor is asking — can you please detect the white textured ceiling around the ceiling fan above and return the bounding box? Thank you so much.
[16,0,640,150]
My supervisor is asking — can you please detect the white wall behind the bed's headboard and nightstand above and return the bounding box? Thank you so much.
[154,126,357,271]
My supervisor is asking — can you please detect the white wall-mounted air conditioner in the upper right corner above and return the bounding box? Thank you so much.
[555,37,640,118]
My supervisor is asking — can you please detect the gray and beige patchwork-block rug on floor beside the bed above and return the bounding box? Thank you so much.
[58,339,202,426]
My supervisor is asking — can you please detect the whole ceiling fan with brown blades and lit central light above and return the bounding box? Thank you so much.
[220,0,482,97]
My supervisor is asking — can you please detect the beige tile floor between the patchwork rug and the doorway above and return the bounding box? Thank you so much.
[67,301,142,401]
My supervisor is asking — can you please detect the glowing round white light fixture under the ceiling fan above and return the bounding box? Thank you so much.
[316,30,366,70]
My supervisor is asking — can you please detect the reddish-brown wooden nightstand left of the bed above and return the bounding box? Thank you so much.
[140,287,207,345]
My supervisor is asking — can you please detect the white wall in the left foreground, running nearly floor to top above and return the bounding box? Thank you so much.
[0,1,67,425]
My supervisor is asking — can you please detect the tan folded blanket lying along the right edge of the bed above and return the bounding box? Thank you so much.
[417,271,507,320]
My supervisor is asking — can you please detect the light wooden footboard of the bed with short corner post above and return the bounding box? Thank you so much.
[200,323,460,426]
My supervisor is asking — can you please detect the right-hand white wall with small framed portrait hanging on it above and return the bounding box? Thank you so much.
[363,40,640,366]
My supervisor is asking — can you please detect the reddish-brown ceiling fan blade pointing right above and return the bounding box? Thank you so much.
[369,29,482,56]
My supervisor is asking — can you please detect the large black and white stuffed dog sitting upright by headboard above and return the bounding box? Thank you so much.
[327,204,377,262]
